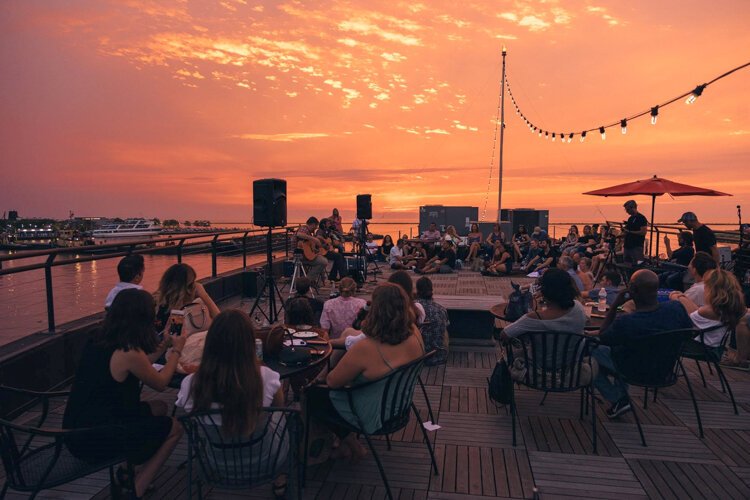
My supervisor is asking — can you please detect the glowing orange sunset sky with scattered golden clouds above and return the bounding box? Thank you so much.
[0,0,750,222]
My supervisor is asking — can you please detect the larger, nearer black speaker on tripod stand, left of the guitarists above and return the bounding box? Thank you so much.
[250,179,286,324]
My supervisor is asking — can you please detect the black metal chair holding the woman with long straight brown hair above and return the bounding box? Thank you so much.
[180,407,302,499]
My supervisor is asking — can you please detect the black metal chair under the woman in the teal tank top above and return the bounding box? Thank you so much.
[304,351,440,500]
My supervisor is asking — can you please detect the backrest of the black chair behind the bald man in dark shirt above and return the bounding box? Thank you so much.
[612,329,698,387]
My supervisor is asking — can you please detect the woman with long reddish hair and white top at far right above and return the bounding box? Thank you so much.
[675,269,747,348]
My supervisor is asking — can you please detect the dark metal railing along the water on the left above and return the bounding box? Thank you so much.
[0,226,296,333]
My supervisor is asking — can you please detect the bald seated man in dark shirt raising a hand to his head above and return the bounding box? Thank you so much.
[592,269,693,418]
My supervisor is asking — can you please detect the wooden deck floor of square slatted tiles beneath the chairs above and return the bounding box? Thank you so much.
[2,276,750,500]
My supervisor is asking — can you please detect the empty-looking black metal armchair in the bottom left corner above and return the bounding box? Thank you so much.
[0,386,135,498]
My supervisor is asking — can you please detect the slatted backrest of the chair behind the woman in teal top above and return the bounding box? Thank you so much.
[331,351,435,435]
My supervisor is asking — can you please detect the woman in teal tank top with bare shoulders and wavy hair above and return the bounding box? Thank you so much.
[305,283,424,460]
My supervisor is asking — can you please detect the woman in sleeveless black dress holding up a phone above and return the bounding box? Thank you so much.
[63,289,186,497]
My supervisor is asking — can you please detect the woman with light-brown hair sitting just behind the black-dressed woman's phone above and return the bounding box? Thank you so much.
[154,264,219,331]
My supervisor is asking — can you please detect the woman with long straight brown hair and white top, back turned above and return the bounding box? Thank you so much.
[175,309,289,495]
